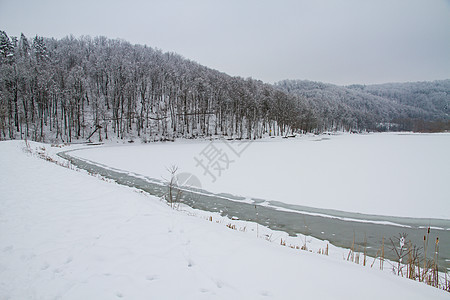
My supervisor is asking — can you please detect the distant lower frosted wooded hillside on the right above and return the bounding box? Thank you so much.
[275,80,450,131]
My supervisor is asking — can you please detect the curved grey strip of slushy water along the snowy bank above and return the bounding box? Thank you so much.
[58,150,450,272]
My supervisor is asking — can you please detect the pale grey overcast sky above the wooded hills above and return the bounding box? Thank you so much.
[0,0,450,84]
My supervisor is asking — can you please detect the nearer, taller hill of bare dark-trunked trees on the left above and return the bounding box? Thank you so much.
[0,31,305,142]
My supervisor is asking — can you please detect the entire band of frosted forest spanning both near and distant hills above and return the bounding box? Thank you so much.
[0,31,450,142]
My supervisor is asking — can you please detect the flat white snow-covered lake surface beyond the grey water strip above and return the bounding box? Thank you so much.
[72,133,450,219]
